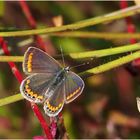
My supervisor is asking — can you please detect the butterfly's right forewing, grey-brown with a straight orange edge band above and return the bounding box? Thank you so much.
[65,71,85,104]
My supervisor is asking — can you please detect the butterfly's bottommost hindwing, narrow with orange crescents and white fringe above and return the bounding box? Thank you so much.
[44,81,65,117]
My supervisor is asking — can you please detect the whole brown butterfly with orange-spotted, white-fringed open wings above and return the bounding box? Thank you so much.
[20,47,85,117]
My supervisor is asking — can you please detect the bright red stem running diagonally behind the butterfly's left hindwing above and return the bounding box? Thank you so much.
[0,37,52,139]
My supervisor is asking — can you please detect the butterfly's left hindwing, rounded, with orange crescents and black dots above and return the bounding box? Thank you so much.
[20,73,55,103]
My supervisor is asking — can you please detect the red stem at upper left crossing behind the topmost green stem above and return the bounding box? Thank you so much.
[19,0,47,50]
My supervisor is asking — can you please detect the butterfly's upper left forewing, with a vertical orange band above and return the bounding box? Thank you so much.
[23,47,61,74]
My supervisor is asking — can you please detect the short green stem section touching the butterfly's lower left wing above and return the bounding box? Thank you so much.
[0,94,24,106]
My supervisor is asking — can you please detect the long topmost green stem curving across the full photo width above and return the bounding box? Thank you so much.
[0,5,140,37]
